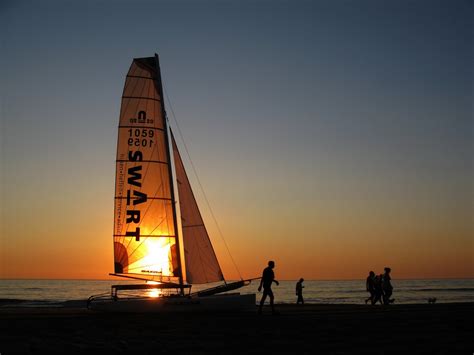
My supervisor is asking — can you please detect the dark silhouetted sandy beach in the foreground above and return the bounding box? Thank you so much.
[0,303,474,354]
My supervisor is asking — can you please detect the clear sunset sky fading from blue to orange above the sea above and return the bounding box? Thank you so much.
[0,0,474,279]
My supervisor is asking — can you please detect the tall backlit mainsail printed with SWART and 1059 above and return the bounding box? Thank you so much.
[114,58,181,279]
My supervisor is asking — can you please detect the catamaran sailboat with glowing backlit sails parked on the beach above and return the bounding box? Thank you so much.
[88,54,255,312]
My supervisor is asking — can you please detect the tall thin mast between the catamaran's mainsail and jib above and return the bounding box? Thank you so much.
[155,53,184,295]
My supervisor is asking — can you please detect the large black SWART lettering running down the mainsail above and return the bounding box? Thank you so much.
[125,151,148,241]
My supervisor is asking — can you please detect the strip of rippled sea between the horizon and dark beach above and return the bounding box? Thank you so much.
[0,279,474,306]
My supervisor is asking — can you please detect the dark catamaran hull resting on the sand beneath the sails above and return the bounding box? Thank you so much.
[89,293,256,313]
